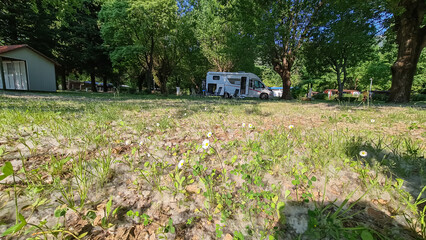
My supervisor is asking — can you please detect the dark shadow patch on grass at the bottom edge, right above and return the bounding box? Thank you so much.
[274,200,423,240]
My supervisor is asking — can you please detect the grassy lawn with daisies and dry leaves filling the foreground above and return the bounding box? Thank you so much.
[0,92,426,240]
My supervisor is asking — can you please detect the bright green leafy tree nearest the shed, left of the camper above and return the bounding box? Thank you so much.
[99,0,177,93]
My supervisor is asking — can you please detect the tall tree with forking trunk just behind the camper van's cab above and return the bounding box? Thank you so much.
[250,0,323,100]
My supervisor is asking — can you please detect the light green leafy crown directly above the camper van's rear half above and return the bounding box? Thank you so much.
[195,0,255,72]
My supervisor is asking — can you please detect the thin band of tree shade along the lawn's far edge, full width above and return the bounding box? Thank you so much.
[0,90,426,113]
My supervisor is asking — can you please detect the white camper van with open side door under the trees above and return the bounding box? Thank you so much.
[206,72,273,99]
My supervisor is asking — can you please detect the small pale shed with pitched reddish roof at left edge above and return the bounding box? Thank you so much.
[0,44,59,92]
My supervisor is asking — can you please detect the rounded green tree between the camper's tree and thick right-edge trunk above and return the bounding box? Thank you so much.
[304,0,376,99]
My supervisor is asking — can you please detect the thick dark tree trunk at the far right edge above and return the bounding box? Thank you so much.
[388,0,426,103]
